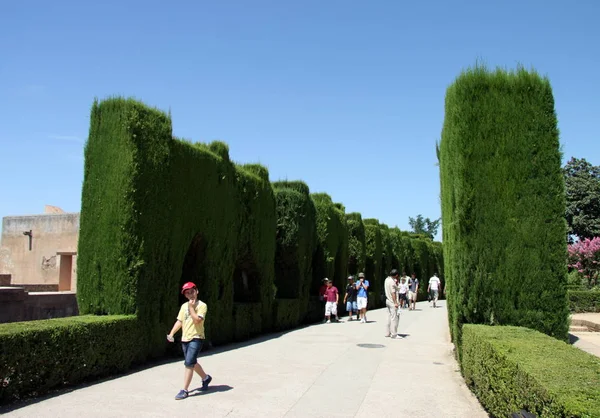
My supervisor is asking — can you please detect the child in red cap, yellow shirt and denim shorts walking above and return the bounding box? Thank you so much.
[167,282,212,400]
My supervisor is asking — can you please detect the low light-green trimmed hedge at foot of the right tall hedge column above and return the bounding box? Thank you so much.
[461,324,600,417]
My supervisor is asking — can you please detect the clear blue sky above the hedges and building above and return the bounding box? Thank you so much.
[0,0,600,238]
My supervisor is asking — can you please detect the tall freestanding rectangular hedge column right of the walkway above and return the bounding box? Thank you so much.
[440,66,568,346]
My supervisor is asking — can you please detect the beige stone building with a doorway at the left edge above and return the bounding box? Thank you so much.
[0,206,79,291]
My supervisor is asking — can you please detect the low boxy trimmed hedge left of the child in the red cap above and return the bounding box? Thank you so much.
[0,316,142,404]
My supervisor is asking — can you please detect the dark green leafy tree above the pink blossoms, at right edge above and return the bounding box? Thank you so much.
[563,157,600,242]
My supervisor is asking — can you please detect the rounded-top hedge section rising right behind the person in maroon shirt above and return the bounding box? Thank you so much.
[310,193,348,294]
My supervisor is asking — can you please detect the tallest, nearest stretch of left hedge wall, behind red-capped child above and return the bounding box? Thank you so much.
[77,98,276,354]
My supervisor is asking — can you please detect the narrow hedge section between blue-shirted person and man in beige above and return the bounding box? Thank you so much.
[363,219,386,309]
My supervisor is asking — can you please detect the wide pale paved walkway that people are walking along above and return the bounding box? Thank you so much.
[0,301,487,418]
